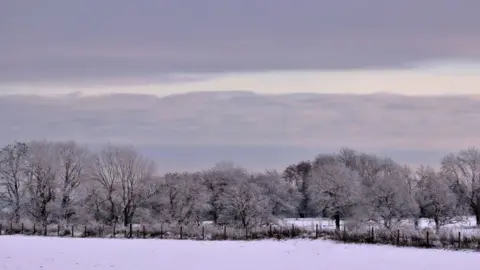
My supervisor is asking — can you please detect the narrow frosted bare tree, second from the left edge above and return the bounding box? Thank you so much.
[26,141,58,226]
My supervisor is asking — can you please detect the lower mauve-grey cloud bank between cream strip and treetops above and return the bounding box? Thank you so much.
[0,92,480,169]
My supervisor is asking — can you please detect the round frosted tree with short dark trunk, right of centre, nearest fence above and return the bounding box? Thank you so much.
[309,162,361,229]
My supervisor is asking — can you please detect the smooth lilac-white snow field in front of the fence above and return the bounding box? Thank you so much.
[0,236,480,270]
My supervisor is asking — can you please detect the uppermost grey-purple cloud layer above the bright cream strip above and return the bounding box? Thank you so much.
[0,0,480,82]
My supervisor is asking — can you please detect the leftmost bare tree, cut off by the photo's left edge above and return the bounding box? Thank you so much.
[0,142,29,223]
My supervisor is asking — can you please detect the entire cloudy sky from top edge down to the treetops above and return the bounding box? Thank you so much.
[0,0,480,171]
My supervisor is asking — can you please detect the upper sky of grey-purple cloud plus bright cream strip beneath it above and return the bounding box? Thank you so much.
[0,0,480,95]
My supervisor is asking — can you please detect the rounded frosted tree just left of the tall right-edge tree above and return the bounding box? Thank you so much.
[416,167,464,232]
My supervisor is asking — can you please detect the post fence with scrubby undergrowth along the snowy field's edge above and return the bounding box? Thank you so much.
[0,223,480,251]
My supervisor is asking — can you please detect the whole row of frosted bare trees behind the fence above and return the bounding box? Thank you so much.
[0,141,480,230]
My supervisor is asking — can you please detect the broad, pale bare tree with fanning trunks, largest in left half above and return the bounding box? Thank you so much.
[91,145,158,226]
